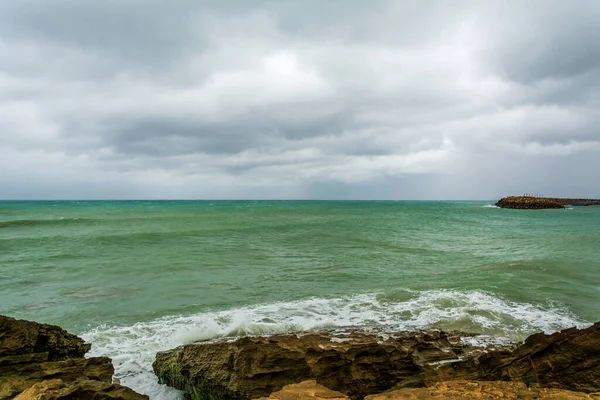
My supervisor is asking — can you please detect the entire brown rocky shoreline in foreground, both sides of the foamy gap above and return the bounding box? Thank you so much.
[0,316,600,400]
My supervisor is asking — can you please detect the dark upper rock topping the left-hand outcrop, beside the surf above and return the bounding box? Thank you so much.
[0,315,91,361]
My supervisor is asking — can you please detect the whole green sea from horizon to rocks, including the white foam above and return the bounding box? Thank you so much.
[0,201,600,399]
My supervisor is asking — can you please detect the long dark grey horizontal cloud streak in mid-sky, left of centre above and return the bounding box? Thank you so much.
[98,109,354,157]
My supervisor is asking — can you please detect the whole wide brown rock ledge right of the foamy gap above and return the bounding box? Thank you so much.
[153,323,600,400]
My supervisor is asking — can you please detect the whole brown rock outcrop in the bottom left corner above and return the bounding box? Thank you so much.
[0,315,148,400]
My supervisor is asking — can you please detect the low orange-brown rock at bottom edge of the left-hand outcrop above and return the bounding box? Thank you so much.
[15,379,149,400]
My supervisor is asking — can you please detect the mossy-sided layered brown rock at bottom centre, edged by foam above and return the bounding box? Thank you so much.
[153,331,496,400]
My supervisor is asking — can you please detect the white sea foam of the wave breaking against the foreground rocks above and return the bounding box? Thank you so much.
[82,290,587,400]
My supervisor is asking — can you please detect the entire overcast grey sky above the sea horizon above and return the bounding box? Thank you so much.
[0,0,600,200]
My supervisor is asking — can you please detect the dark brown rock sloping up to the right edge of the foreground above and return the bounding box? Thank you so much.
[398,322,600,393]
